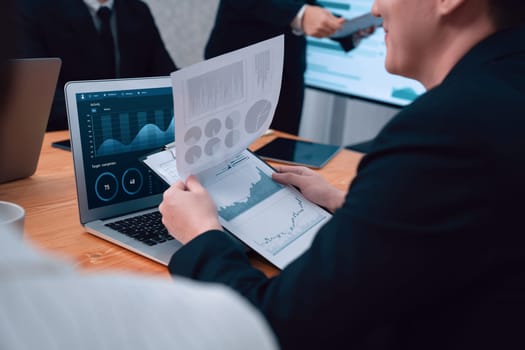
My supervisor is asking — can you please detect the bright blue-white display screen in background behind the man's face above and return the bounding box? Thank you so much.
[305,0,425,107]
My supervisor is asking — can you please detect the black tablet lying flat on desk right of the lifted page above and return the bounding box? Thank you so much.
[255,137,341,169]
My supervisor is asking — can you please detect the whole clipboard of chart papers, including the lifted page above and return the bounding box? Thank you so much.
[143,36,331,268]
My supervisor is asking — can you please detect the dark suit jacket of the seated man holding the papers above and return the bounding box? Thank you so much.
[169,28,525,349]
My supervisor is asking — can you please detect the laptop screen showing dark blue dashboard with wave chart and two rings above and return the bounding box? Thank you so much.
[74,87,175,209]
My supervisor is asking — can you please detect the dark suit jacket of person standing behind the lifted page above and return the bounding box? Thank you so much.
[204,0,315,134]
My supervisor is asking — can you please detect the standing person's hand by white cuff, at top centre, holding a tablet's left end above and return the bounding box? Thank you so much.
[302,5,345,38]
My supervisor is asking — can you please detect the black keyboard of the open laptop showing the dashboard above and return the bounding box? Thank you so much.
[105,211,173,246]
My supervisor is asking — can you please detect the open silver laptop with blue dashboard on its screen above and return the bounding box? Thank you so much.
[64,76,182,265]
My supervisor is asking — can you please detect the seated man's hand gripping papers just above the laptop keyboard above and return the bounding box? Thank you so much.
[159,176,222,244]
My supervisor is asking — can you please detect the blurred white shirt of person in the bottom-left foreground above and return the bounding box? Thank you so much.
[0,227,277,350]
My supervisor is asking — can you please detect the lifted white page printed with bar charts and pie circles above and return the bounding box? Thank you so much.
[171,35,284,179]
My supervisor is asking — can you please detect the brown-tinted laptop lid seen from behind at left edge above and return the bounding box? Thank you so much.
[0,58,61,183]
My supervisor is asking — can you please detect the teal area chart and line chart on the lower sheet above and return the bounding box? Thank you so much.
[206,154,329,255]
